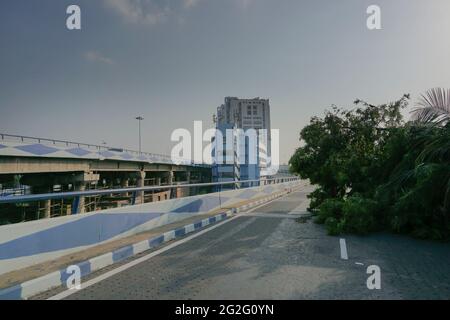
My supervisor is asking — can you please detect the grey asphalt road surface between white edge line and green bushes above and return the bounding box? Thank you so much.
[37,192,450,299]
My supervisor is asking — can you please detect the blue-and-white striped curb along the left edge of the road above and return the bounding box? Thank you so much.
[0,188,292,300]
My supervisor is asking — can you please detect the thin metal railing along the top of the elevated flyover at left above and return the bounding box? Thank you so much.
[0,133,211,167]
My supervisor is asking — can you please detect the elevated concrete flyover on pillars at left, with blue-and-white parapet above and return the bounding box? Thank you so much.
[0,134,211,218]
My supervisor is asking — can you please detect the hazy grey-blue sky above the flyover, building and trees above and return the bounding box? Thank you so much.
[0,0,450,163]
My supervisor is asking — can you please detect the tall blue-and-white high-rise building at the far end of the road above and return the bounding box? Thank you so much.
[213,97,271,186]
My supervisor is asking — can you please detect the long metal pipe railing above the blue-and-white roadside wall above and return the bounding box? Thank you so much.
[0,177,300,204]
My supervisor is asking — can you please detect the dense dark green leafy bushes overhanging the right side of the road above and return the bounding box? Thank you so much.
[290,91,450,240]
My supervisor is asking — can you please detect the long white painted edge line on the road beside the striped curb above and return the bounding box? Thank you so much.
[47,192,290,300]
